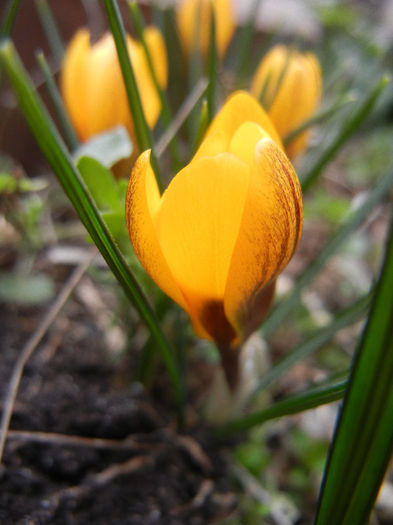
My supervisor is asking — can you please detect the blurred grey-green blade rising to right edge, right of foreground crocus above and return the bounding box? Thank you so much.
[262,171,393,337]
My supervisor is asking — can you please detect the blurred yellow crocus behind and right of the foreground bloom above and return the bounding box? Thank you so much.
[251,45,322,158]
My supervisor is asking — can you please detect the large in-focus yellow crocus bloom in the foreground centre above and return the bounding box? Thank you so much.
[126,92,302,387]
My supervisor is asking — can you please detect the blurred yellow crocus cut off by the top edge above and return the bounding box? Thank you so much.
[177,0,235,58]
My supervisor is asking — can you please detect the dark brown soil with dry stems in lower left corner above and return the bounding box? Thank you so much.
[0,301,235,525]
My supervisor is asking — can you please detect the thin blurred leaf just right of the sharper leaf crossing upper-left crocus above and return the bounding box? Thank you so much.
[128,0,182,172]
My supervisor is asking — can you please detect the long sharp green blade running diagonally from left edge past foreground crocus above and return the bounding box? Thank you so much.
[0,39,184,421]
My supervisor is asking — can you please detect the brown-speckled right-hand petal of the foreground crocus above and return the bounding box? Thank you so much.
[224,138,302,338]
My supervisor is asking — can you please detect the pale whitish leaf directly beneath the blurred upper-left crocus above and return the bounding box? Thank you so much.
[74,126,132,168]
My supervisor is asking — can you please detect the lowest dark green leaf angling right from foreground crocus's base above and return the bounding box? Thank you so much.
[214,374,347,436]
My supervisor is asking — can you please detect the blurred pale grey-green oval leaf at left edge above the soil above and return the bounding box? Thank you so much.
[0,273,56,306]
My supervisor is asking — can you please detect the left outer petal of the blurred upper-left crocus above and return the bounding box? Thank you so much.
[60,29,90,137]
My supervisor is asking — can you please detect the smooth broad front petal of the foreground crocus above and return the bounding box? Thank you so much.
[155,153,250,342]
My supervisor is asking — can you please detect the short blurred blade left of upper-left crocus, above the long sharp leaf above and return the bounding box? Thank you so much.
[36,51,79,151]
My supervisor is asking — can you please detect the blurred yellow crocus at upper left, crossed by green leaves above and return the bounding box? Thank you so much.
[61,27,167,144]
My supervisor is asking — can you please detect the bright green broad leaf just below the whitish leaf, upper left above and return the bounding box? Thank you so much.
[76,157,124,216]
